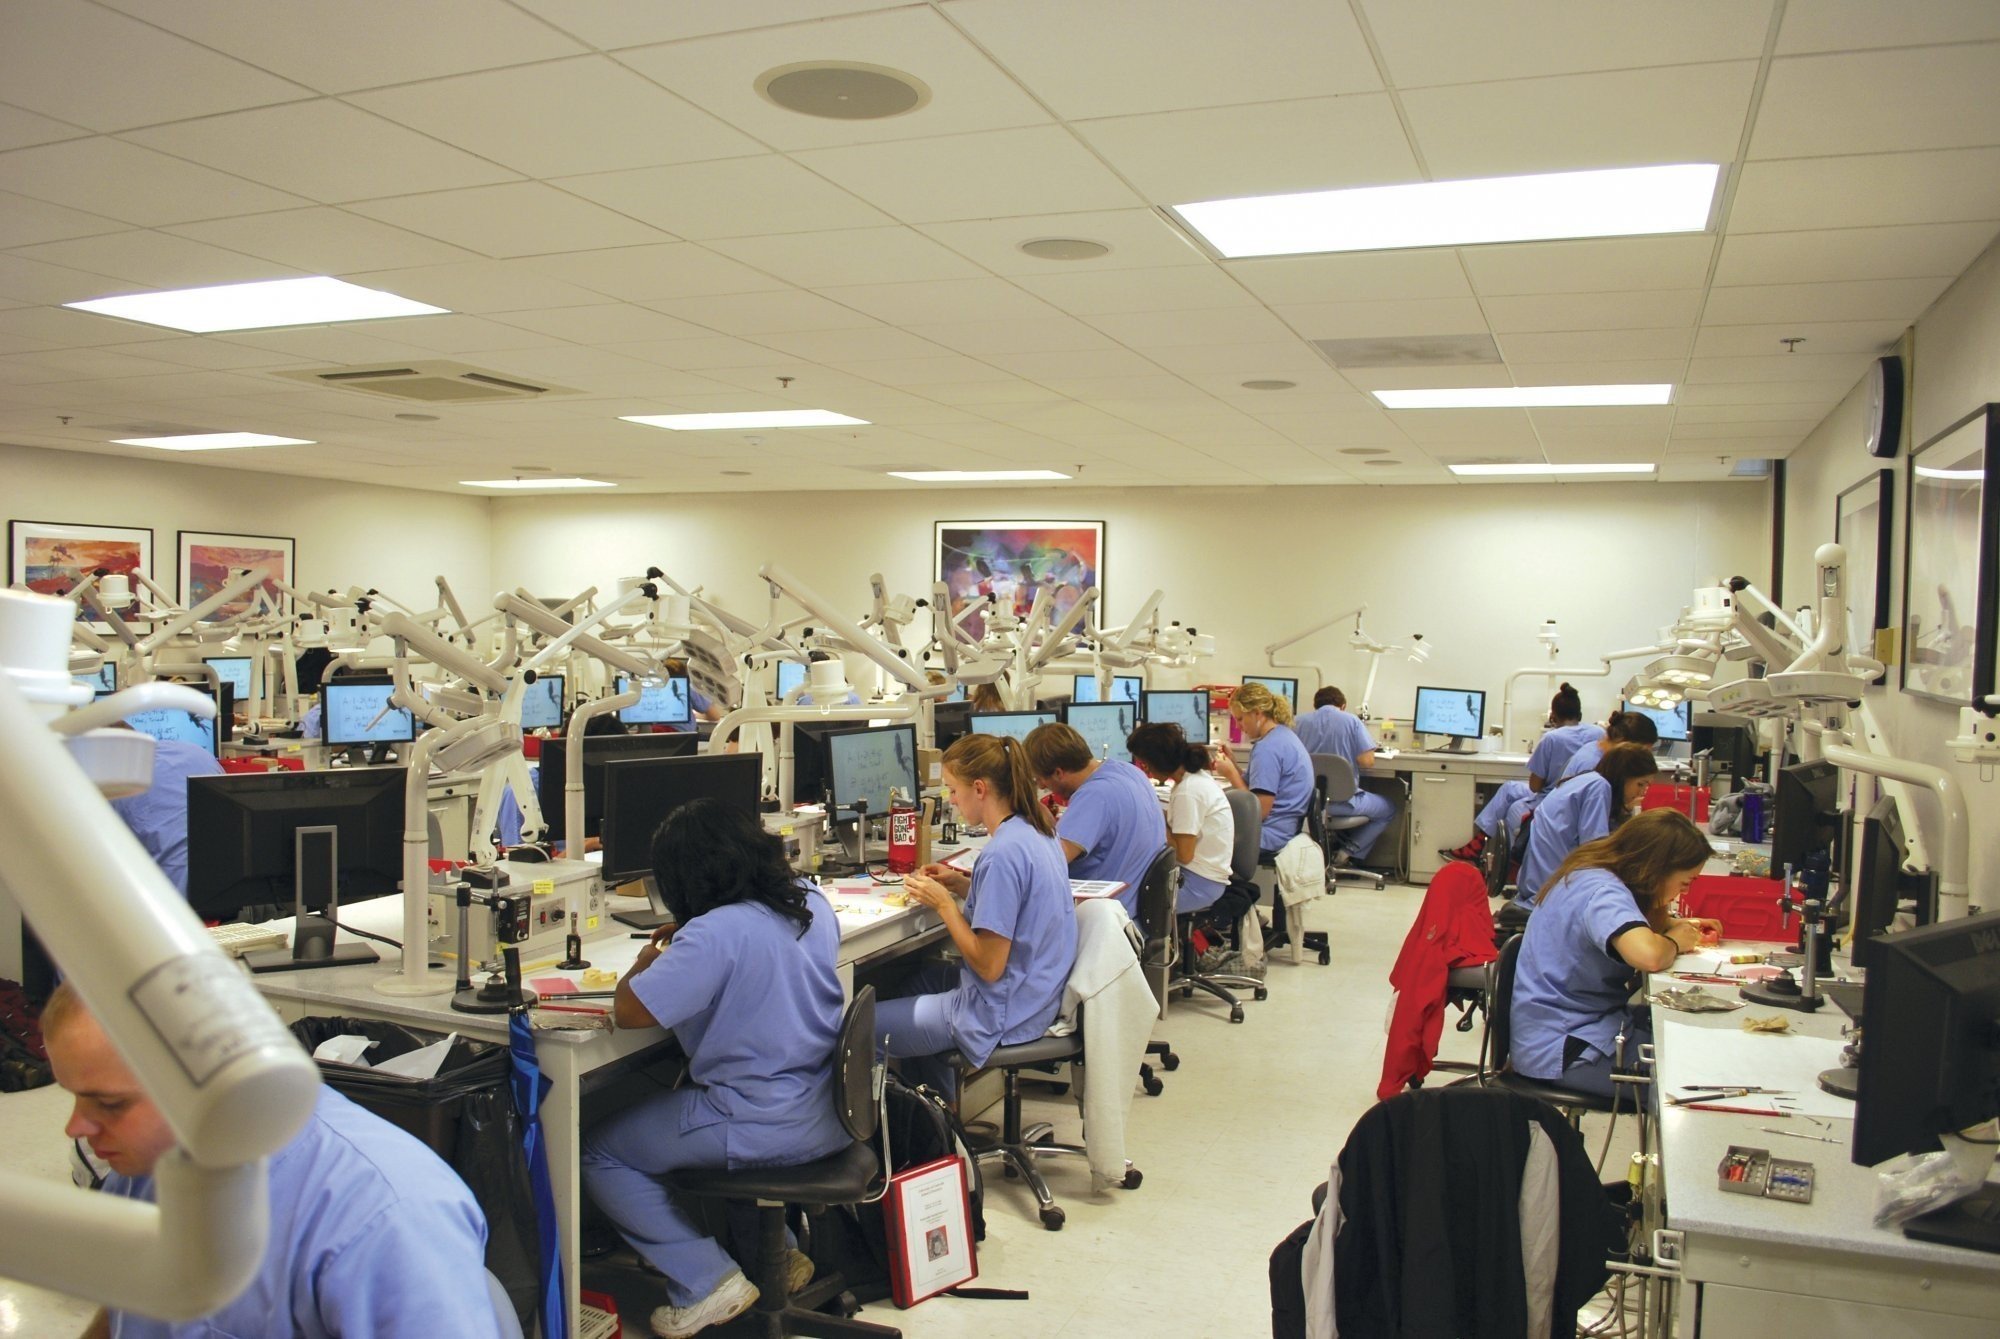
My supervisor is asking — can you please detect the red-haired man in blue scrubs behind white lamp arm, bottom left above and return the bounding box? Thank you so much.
[42,985,500,1339]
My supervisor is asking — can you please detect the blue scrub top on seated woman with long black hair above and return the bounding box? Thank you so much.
[632,885,848,1167]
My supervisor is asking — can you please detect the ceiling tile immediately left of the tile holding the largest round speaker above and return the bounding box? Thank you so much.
[350,56,762,178]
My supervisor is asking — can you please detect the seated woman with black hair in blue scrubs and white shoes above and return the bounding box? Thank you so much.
[580,799,848,1339]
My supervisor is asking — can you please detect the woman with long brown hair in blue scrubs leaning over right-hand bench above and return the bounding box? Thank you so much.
[1512,809,1722,1097]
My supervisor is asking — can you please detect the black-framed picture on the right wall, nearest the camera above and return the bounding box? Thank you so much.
[1902,404,2000,705]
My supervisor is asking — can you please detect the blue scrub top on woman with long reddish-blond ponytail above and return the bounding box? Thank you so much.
[946,815,1076,1065]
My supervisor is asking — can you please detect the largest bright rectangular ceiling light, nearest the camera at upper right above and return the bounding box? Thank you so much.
[1172,162,1722,260]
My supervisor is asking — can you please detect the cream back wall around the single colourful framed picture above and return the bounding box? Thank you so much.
[494,484,1770,739]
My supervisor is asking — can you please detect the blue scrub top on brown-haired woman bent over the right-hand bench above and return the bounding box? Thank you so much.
[1512,867,1646,1079]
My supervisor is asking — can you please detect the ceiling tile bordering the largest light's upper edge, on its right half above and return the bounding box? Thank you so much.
[1402,60,1756,180]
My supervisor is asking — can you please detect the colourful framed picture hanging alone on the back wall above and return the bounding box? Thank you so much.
[932,520,1104,638]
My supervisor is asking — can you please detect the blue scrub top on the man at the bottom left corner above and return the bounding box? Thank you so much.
[104,1087,498,1339]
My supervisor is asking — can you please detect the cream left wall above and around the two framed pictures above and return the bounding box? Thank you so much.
[0,444,494,614]
